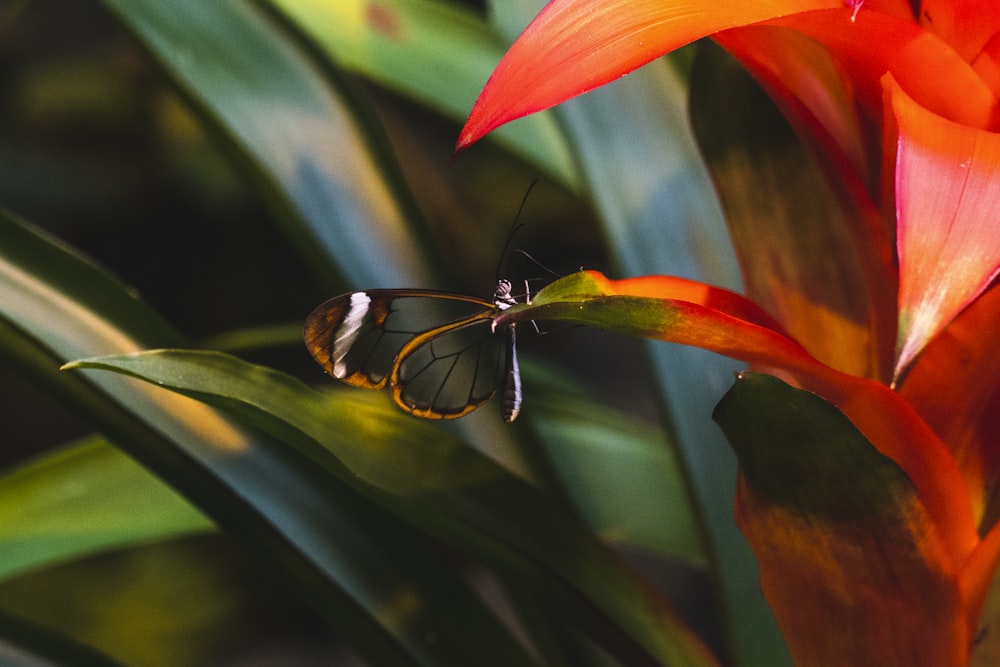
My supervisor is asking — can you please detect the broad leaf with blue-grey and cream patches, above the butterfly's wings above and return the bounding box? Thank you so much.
[104,0,434,287]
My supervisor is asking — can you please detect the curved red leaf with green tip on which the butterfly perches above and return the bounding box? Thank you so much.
[496,271,978,563]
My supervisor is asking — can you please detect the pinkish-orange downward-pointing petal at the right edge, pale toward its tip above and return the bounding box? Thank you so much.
[886,78,1000,378]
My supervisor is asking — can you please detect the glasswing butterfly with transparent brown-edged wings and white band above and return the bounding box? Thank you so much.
[304,280,521,423]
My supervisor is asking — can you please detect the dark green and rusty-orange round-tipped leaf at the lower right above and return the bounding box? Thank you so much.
[714,373,972,667]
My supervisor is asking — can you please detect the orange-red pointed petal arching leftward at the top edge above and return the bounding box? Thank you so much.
[456,0,849,150]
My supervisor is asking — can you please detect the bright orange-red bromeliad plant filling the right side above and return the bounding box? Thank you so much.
[458,0,1000,666]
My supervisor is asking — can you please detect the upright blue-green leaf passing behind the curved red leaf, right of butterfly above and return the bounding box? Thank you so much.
[491,6,760,665]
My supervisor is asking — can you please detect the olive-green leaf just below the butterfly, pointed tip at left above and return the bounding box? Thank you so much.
[72,350,713,665]
